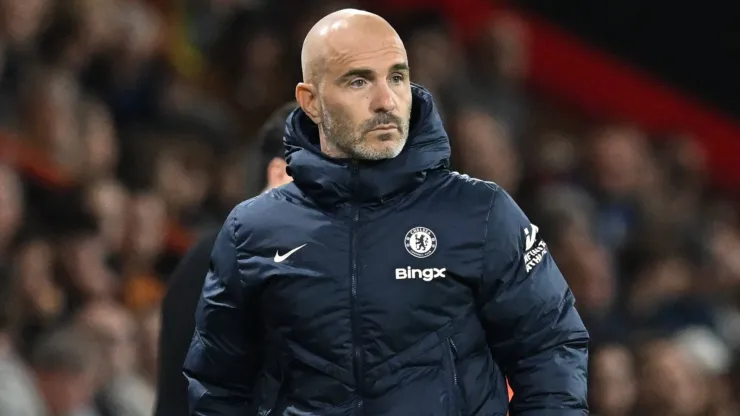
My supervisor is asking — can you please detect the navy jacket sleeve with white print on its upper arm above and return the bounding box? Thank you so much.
[478,188,589,416]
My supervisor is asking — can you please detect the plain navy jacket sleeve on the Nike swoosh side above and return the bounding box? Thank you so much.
[183,207,261,416]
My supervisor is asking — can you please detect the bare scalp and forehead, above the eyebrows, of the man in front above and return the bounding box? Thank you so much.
[301,9,406,83]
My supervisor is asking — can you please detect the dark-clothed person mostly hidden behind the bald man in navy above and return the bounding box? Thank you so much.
[156,102,298,416]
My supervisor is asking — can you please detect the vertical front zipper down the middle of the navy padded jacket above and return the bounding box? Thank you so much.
[350,161,363,414]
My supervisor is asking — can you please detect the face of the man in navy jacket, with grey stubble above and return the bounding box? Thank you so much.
[318,34,411,160]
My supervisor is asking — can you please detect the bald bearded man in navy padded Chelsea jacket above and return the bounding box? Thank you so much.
[184,10,589,416]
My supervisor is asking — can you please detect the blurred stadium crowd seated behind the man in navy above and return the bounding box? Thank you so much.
[0,0,740,416]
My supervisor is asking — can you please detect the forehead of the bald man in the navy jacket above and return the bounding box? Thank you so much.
[326,33,407,73]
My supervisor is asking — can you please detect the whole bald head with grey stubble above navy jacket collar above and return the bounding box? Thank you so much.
[296,9,412,160]
